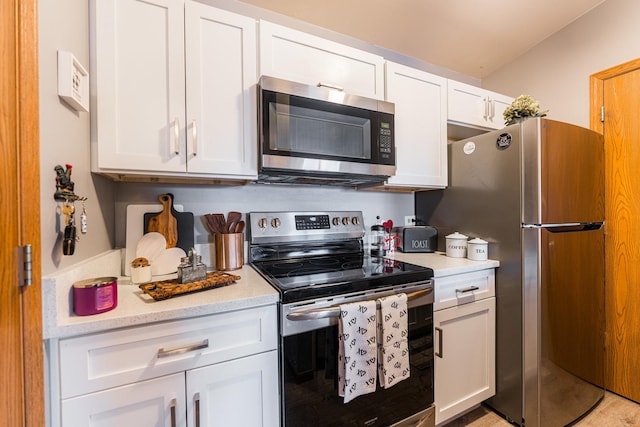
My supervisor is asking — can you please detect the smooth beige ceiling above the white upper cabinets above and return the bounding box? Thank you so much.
[242,0,605,79]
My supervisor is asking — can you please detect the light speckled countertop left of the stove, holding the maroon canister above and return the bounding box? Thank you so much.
[42,250,279,339]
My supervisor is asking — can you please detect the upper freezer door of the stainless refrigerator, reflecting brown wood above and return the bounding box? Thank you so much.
[522,119,604,224]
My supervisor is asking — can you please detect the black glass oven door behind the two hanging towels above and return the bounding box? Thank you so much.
[280,282,434,427]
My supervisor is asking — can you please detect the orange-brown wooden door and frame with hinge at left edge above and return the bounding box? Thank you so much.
[0,0,44,427]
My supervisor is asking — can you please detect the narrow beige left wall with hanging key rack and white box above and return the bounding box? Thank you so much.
[38,0,114,275]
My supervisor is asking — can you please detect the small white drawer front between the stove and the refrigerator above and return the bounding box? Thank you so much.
[433,268,496,311]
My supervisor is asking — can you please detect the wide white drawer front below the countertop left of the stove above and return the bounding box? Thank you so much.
[59,305,278,399]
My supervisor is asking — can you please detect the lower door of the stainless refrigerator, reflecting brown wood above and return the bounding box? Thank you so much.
[523,224,605,427]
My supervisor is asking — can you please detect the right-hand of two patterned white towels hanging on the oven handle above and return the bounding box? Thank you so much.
[378,294,411,388]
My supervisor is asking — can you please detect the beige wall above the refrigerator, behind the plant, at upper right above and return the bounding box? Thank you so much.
[482,0,640,127]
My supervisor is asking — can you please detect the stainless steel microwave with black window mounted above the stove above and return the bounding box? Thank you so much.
[258,76,396,187]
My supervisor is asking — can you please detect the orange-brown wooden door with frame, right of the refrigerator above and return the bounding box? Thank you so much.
[591,59,640,402]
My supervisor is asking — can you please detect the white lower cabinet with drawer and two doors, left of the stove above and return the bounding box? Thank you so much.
[49,306,280,427]
